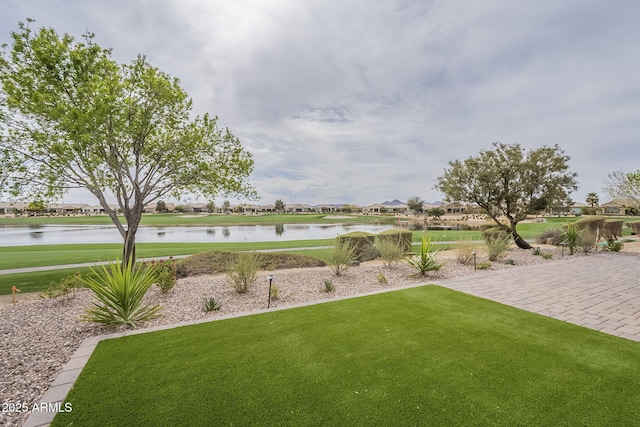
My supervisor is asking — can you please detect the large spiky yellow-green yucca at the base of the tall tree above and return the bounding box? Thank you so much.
[81,260,161,328]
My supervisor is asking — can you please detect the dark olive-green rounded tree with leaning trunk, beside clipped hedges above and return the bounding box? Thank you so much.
[435,142,577,249]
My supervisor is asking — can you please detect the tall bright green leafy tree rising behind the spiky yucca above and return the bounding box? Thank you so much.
[0,20,255,262]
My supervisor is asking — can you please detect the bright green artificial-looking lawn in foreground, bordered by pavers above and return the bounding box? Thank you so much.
[52,286,640,426]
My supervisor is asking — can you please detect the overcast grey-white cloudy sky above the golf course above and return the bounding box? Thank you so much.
[0,0,640,205]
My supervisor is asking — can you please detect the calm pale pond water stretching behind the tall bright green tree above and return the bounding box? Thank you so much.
[0,224,393,246]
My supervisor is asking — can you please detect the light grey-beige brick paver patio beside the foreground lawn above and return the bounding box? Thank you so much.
[436,253,640,341]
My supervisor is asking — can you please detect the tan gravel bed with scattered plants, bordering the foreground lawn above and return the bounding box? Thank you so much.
[0,247,632,425]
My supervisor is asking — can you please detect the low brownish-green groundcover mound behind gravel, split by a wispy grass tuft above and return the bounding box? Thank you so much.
[176,251,327,277]
